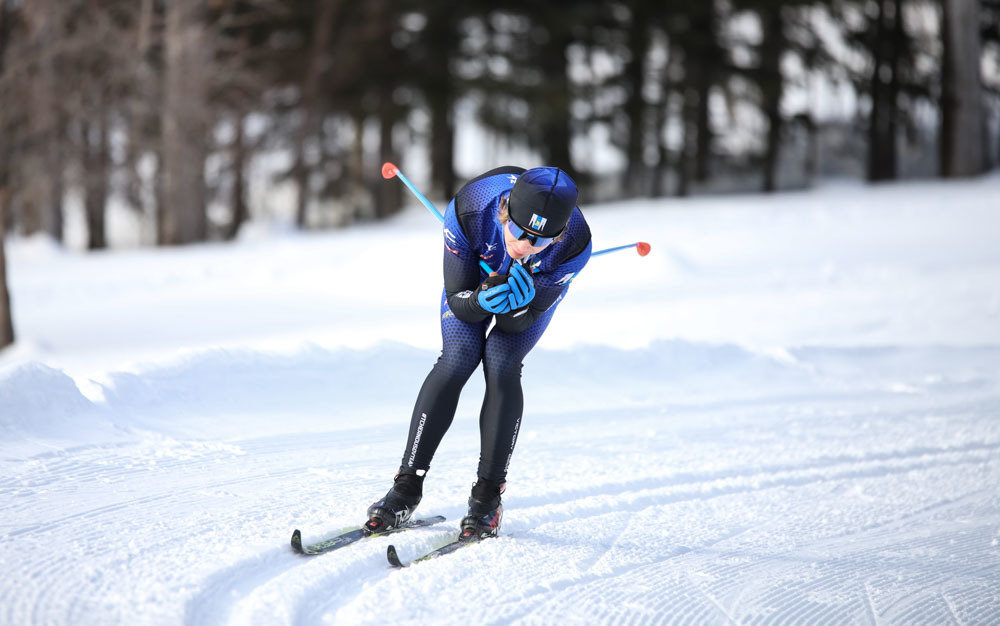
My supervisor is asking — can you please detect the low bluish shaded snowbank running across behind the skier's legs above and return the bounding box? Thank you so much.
[80,339,1000,438]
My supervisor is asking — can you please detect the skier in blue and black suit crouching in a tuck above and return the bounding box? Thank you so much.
[365,166,591,540]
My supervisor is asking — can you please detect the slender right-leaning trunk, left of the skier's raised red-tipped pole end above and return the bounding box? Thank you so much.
[292,0,337,228]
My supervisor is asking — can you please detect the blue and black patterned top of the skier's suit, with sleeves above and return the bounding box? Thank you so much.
[443,166,591,333]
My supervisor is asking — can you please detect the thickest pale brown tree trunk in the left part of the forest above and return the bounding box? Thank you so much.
[159,0,212,245]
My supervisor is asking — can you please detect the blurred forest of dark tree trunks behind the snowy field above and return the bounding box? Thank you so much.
[0,0,1000,347]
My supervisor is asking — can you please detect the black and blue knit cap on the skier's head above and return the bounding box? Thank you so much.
[507,167,577,237]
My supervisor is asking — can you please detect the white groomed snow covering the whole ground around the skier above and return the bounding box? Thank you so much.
[0,177,1000,625]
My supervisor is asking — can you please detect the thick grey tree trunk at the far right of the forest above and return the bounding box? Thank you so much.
[940,0,985,178]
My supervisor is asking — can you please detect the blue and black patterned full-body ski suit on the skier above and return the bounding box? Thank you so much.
[402,166,591,482]
